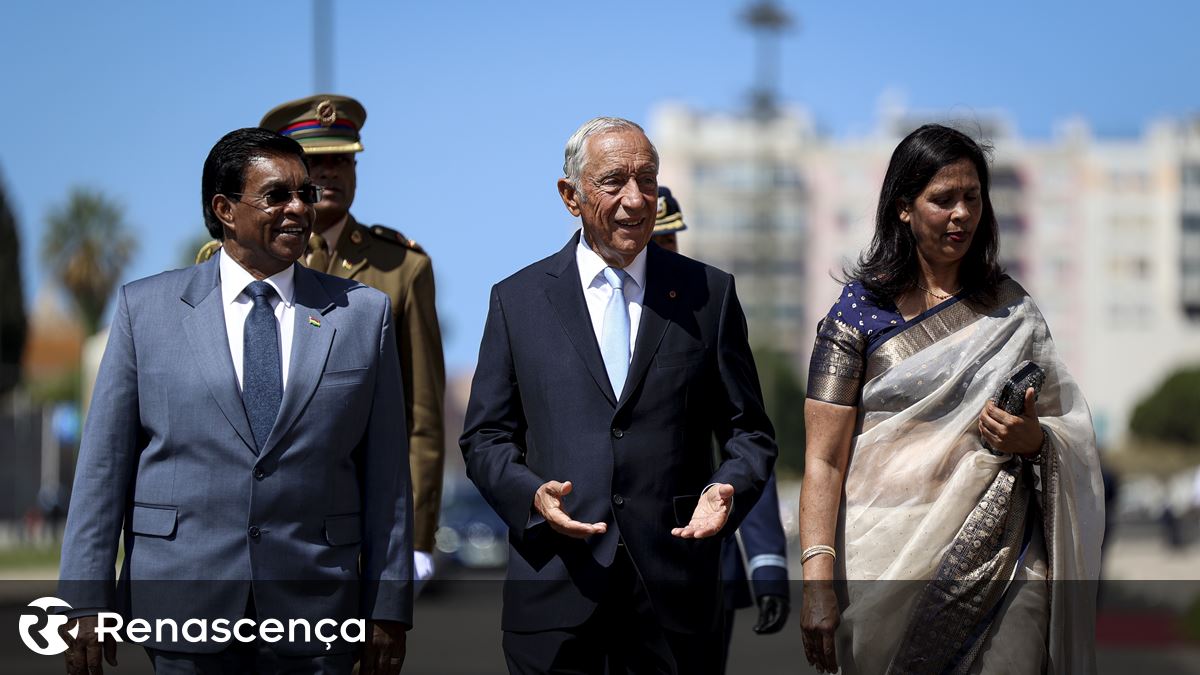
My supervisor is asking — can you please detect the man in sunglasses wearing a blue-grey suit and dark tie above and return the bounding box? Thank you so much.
[59,129,413,674]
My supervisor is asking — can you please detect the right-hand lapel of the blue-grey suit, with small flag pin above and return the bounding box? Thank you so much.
[263,264,336,456]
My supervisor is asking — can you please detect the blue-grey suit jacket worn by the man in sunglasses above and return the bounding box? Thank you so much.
[60,253,413,653]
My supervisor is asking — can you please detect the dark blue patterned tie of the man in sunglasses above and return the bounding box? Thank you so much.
[241,281,283,450]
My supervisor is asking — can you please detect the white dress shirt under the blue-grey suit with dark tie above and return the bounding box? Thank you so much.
[217,250,296,390]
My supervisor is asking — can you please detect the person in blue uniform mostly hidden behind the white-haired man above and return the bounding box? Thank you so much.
[652,185,790,667]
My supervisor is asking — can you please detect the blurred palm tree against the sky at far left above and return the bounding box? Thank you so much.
[42,187,137,335]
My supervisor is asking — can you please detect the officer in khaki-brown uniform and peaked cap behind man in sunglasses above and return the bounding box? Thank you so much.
[259,94,445,580]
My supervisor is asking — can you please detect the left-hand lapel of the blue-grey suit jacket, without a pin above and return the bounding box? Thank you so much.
[180,256,258,453]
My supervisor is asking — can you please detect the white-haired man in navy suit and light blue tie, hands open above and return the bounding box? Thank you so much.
[461,118,776,675]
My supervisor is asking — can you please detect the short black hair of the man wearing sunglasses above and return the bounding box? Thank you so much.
[200,127,308,239]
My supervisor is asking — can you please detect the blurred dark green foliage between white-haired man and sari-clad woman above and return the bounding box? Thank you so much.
[754,347,804,474]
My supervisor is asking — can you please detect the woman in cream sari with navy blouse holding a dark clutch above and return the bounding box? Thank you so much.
[800,125,1104,674]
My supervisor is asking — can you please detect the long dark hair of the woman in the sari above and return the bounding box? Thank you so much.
[842,124,1003,303]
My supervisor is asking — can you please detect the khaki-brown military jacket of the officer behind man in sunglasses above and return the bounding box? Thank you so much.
[301,215,445,551]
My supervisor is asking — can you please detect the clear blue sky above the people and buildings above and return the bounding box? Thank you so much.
[0,0,1200,368]
